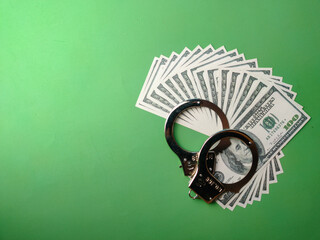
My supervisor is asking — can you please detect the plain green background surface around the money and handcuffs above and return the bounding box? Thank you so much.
[0,0,320,240]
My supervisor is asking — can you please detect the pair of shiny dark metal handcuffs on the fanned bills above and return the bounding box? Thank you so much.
[165,99,259,203]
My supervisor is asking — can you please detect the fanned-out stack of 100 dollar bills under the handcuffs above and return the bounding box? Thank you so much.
[136,45,310,210]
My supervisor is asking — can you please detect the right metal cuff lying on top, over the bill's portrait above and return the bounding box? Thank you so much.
[189,130,258,203]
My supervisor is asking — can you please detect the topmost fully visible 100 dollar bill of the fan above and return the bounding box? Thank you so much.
[216,85,310,206]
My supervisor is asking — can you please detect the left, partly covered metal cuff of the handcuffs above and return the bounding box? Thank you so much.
[165,99,230,176]
